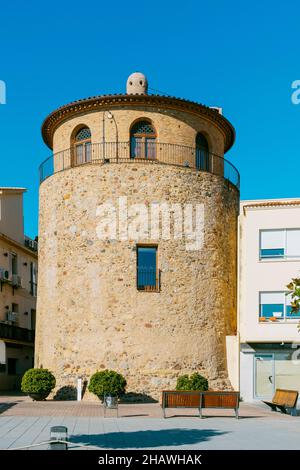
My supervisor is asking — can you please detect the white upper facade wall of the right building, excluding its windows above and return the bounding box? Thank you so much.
[239,199,300,344]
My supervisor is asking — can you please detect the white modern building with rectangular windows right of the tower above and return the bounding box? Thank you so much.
[239,199,300,401]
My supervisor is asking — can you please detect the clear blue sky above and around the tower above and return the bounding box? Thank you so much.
[0,0,300,236]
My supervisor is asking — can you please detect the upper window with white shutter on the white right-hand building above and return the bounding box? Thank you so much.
[260,229,300,259]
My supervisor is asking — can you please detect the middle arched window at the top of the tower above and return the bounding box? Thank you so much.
[130,121,156,160]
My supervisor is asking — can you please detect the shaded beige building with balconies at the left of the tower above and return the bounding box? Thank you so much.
[0,188,37,390]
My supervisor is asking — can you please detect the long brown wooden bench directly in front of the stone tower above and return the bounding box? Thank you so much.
[161,390,240,418]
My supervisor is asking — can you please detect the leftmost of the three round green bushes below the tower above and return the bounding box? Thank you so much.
[21,369,56,398]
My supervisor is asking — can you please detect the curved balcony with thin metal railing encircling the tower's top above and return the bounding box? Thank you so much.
[39,142,240,189]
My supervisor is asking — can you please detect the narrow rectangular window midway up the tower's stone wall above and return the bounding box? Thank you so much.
[137,245,158,292]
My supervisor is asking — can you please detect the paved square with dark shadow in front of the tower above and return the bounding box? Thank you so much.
[0,397,300,450]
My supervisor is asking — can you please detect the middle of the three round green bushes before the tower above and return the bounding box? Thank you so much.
[88,369,127,400]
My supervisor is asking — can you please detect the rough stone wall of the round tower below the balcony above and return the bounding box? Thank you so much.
[35,162,238,398]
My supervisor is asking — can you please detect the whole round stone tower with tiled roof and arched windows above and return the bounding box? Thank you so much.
[35,73,239,397]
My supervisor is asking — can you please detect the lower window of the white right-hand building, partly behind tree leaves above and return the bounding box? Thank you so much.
[259,292,300,322]
